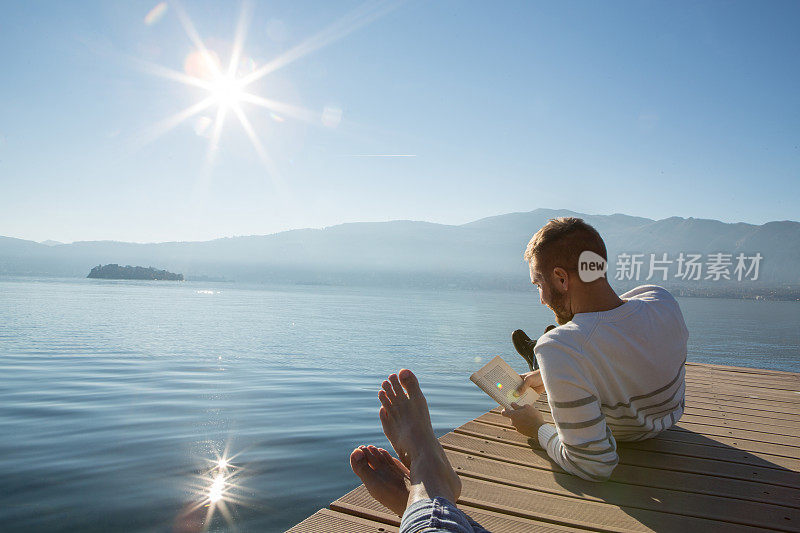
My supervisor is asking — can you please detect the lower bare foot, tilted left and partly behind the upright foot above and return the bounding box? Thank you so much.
[350,446,411,516]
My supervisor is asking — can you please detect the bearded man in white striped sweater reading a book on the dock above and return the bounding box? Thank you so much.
[502,217,689,481]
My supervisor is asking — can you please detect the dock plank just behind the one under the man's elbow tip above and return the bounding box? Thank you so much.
[456,422,800,487]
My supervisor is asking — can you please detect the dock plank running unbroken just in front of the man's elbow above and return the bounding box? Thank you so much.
[448,451,800,527]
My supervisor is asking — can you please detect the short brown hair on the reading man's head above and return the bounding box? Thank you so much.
[523,217,608,272]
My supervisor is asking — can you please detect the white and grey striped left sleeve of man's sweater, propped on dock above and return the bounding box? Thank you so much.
[538,348,619,481]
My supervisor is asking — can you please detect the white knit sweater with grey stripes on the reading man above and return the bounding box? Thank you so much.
[534,285,689,481]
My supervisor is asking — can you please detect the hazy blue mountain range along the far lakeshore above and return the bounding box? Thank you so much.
[0,209,800,294]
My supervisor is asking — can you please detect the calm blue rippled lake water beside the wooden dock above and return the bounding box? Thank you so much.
[0,278,800,532]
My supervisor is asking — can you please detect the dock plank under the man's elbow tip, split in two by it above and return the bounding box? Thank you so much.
[442,433,800,508]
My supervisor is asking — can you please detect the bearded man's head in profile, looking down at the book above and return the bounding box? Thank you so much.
[524,217,608,324]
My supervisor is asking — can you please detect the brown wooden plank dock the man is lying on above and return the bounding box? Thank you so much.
[289,363,800,533]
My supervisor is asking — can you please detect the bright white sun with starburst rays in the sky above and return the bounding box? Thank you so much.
[138,0,399,191]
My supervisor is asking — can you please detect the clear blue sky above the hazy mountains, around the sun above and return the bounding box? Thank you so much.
[0,0,800,242]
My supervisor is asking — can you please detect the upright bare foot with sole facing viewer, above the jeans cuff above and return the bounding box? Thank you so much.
[378,369,461,503]
